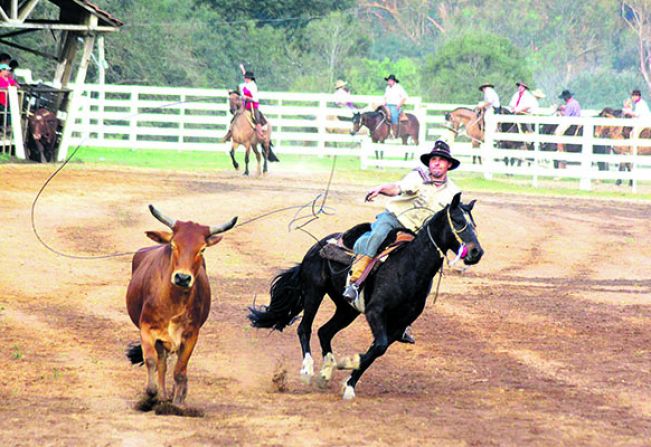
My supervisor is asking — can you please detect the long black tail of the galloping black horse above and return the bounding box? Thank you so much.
[249,264,304,331]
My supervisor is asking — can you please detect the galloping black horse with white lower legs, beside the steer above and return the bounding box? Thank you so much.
[249,193,484,399]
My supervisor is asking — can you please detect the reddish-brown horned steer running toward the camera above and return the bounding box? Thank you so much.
[127,205,237,405]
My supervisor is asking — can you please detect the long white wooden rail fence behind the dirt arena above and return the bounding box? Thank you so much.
[54,85,651,190]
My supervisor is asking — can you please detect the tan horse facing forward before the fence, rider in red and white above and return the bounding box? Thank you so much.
[222,91,279,175]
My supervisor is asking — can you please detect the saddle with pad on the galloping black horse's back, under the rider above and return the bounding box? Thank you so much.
[319,223,416,283]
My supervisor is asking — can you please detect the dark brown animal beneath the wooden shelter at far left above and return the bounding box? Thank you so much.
[25,107,59,163]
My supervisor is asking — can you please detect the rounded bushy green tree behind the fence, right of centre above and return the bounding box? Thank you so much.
[424,33,532,103]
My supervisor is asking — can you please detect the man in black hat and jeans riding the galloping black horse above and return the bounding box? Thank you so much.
[343,140,460,343]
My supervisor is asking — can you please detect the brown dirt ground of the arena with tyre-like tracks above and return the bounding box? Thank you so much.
[0,165,651,446]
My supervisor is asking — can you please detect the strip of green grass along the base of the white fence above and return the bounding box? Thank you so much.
[5,147,651,200]
